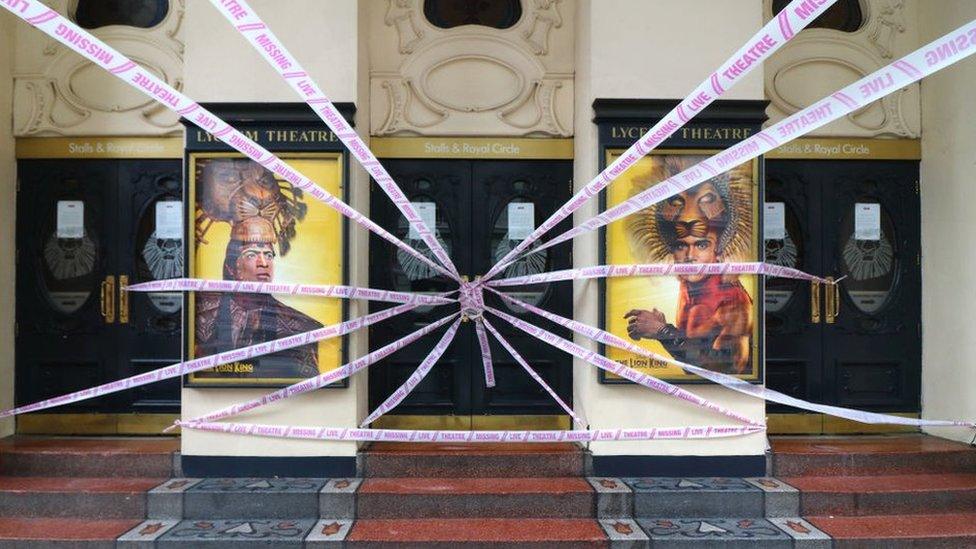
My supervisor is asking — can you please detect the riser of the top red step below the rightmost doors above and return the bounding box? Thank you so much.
[773,452,976,477]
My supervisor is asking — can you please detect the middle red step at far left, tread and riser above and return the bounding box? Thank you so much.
[0,477,165,519]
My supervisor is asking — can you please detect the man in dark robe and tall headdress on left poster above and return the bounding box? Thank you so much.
[195,160,322,379]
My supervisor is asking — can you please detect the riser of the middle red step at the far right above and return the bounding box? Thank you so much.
[800,490,976,516]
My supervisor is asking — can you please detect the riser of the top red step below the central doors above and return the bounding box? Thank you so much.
[361,453,584,478]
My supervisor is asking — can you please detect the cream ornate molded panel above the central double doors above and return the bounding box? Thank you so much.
[368,0,574,137]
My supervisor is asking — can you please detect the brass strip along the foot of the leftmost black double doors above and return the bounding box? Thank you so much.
[17,414,180,435]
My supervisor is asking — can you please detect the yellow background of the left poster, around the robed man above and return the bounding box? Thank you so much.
[186,153,345,386]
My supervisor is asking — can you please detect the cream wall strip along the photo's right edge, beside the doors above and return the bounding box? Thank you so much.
[918,0,976,442]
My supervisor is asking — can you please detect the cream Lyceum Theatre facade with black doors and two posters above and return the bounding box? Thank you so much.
[0,0,976,475]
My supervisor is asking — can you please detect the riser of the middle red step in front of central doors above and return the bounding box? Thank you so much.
[356,494,596,519]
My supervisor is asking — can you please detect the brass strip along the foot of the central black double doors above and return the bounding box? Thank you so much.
[372,415,572,431]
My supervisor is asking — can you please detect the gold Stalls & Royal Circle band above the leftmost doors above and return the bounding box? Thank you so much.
[16,136,183,160]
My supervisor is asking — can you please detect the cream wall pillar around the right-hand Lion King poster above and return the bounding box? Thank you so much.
[573,0,765,455]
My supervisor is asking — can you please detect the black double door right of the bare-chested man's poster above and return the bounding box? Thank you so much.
[764,160,921,412]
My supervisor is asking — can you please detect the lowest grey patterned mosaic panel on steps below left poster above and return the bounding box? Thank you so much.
[158,519,316,544]
